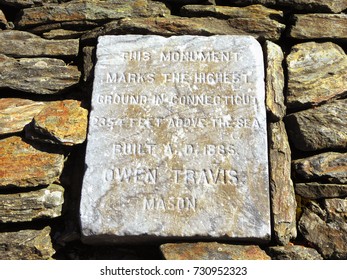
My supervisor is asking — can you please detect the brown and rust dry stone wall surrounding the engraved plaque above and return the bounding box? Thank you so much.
[0,0,347,259]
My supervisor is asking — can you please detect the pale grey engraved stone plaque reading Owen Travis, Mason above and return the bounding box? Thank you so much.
[80,35,270,242]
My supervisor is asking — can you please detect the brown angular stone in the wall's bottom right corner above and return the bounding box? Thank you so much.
[299,201,347,259]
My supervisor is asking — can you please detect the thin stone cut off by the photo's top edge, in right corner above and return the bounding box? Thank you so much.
[229,0,347,13]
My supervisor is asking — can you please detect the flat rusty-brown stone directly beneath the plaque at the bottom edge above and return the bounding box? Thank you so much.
[160,242,271,260]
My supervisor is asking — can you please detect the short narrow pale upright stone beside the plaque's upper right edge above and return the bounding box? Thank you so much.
[265,41,286,121]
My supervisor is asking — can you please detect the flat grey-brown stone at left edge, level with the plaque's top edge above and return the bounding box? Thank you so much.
[0,30,79,57]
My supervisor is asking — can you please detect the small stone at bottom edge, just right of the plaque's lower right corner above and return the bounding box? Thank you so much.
[267,245,323,260]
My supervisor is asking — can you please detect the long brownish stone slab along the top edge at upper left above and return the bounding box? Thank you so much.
[16,0,170,29]
